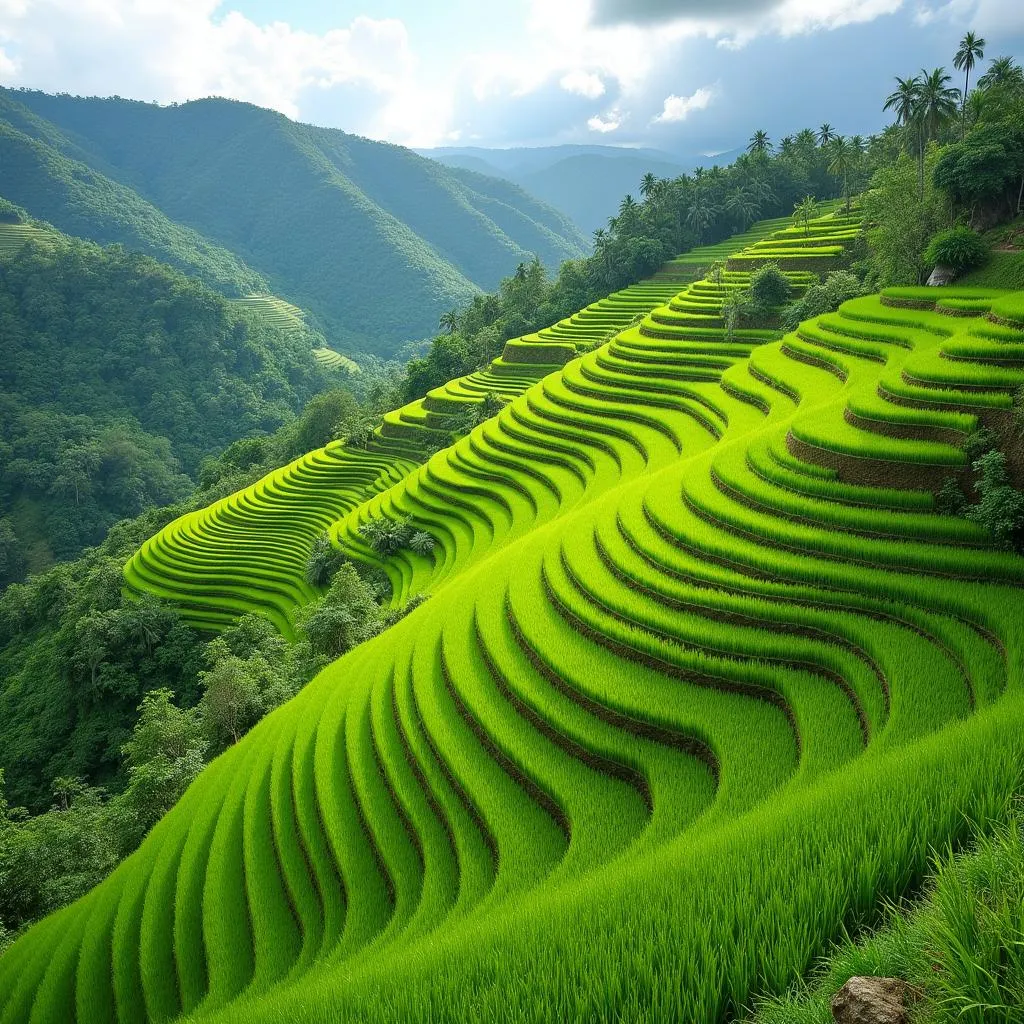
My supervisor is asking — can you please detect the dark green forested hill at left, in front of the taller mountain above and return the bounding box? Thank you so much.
[0,200,327,586]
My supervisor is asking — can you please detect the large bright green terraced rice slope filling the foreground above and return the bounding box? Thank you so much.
[0,211,1024,1022]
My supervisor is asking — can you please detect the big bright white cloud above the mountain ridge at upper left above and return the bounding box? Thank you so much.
[0,0,449,144]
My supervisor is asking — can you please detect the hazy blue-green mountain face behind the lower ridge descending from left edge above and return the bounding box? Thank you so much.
[0,93,584,352]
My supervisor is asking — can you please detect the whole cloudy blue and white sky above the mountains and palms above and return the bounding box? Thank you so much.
[0,0,1024,157]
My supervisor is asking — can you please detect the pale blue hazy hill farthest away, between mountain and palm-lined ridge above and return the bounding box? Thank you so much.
[419,145,688,233]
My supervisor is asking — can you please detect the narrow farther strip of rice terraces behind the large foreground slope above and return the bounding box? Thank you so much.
[126,216,851,636]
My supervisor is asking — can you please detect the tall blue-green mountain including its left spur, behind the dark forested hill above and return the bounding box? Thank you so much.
[0,91,585,354]
